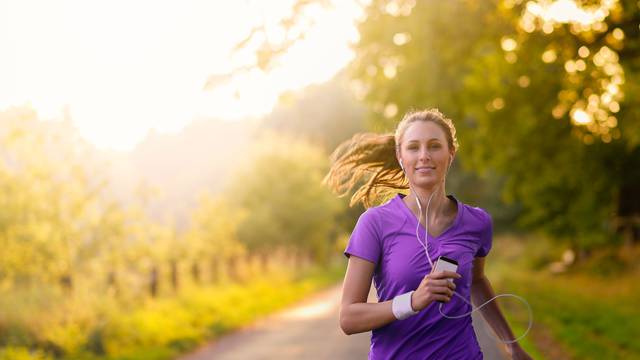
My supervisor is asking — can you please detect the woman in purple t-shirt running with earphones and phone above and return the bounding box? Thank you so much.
[324,109,531,360]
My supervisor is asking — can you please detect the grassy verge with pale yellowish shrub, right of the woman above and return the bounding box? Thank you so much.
[487,235,640,359]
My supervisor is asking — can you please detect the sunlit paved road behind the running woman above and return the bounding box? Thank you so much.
[179,284,507,360]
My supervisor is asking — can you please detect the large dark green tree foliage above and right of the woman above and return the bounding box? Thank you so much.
[352,0,640,249]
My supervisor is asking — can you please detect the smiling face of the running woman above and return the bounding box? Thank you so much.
[399,121,453,188]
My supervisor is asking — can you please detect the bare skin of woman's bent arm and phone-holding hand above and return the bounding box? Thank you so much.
[340,255,460,335]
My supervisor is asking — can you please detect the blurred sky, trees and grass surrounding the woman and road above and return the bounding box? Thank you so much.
[0,0,640,359]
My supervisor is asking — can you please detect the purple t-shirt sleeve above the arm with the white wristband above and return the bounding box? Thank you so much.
[344,209,382,265]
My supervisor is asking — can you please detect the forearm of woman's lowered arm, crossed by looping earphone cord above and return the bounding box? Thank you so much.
[471,277,515,341]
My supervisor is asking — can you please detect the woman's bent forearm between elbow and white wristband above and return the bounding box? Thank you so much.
[340,300,396,335]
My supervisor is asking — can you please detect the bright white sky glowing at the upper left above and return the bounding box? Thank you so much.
[0,0,360,150]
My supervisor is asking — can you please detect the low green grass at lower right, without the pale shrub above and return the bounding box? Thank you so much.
[502,262,640,359]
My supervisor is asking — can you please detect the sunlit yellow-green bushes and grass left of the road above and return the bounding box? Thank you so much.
[0,108,350,359]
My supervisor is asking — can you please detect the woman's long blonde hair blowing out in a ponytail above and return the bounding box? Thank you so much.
[322,109,459,208]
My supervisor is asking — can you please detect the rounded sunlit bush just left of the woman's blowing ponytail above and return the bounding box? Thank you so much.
[226,133,339,260]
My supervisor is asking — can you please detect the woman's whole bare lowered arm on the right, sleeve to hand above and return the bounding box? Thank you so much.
[471,257,532,359]
